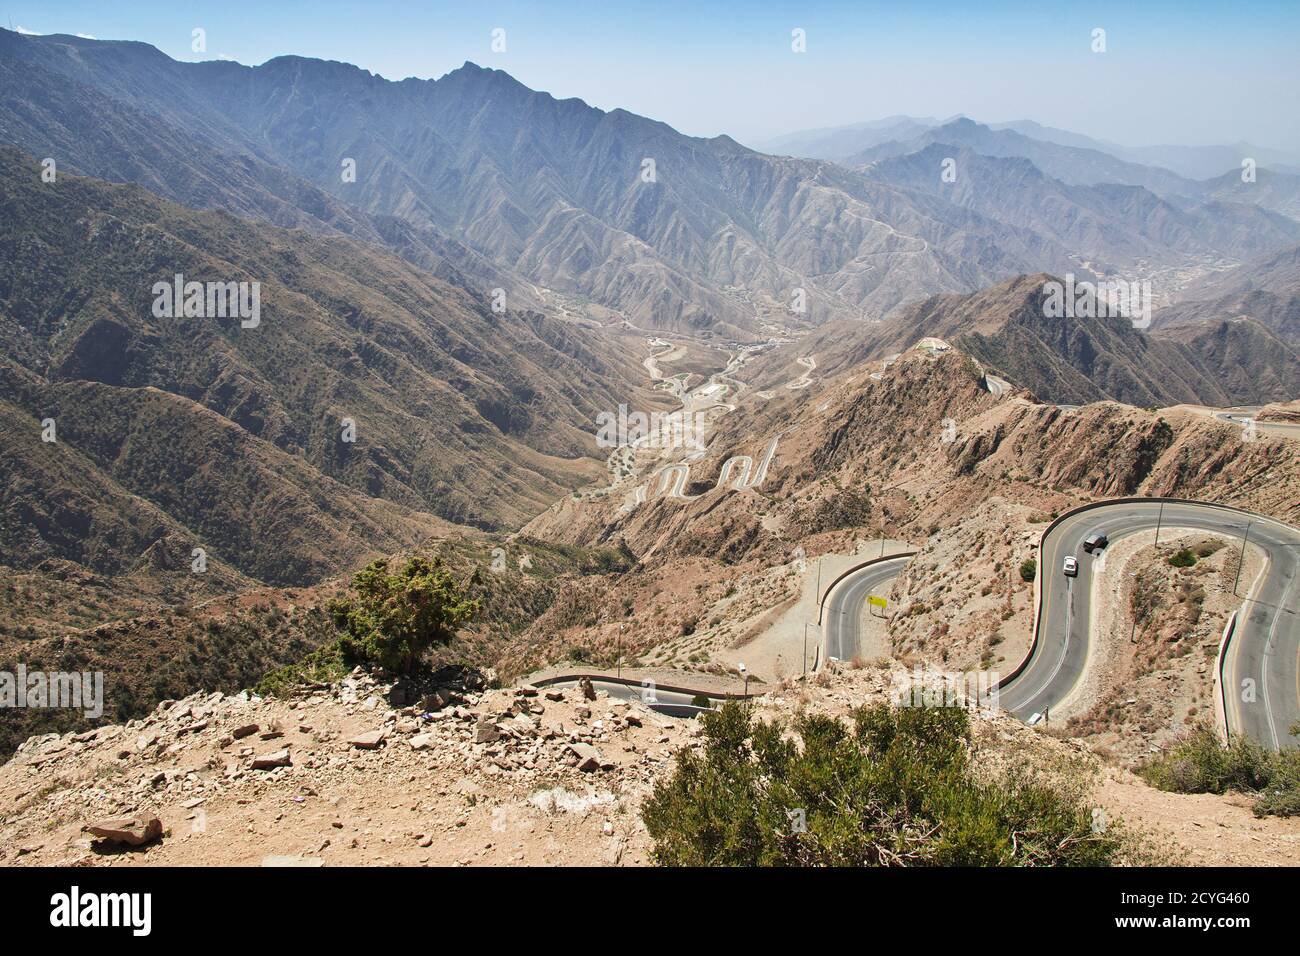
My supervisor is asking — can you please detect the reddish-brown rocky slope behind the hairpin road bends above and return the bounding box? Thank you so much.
[512,335,1300,678]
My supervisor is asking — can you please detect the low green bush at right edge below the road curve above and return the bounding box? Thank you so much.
[1138,724,1300,817]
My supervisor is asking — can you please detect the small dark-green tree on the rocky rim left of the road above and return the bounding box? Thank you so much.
[329,558,478,672]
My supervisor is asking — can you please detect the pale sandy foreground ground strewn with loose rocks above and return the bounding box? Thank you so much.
[0,667,1300,866]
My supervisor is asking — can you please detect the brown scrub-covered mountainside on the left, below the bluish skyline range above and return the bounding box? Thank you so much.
[0,151,641,527]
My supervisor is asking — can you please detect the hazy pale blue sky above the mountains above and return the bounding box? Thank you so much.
[10,0,1300,148]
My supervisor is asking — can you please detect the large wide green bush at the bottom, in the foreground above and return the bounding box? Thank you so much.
[642,701,1128,866]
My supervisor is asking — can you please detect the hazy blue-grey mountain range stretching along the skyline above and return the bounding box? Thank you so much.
[0,31,1300,341]
